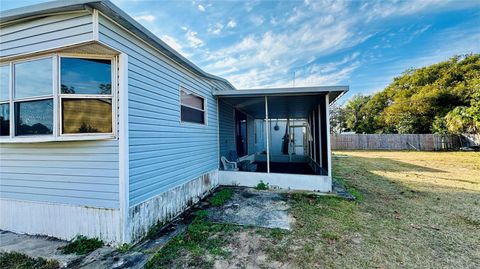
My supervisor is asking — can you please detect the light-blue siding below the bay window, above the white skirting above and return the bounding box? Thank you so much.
[0,140,119,208]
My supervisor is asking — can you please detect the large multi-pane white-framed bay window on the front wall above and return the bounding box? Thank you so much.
[0,55,115,140]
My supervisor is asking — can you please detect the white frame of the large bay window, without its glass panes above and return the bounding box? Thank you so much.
[0,53,118,143]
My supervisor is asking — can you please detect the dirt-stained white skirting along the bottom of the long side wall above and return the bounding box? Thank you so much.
[126,169,218,242]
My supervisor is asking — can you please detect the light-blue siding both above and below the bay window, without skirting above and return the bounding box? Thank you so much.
[0,11,119,208]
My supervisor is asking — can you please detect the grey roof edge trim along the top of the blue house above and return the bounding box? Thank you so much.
[0,0,235,89]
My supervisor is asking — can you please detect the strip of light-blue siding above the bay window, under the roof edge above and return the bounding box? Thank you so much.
[0,11,93,57]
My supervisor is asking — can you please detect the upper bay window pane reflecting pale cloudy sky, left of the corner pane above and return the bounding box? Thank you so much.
[15,58,53,98]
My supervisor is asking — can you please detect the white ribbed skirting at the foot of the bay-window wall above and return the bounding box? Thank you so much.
[0,198,120,243]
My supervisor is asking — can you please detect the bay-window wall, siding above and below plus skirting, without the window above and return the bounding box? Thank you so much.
[0,11,120,242]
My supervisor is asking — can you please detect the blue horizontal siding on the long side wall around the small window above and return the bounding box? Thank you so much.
[99,13,229,206]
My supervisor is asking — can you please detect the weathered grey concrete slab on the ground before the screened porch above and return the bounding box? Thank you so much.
[207,187,294,230]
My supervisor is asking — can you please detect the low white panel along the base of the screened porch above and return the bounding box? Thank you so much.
[218,170,332,192]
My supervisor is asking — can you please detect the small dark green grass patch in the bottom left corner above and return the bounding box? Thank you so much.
[0,252,60,269]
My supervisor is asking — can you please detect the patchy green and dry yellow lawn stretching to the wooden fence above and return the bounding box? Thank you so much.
[147,151,480,268]
